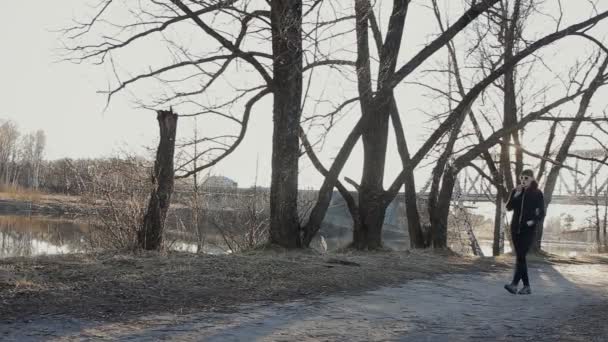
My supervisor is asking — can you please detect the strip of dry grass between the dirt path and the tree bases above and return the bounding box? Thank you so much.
[0,251,510,320]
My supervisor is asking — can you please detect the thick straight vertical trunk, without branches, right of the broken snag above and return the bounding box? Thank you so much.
[270,0,302,248]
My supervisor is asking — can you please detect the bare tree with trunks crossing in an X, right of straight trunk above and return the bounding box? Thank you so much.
[304,0,504,249]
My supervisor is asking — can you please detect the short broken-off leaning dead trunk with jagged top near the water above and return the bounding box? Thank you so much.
[138,110,177,250]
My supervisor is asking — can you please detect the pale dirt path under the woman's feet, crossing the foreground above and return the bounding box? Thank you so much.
[0,264,608,342]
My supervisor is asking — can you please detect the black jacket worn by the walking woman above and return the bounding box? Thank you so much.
[507,184,545,232]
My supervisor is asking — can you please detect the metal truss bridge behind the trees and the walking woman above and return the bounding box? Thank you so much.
[418,149,608,205]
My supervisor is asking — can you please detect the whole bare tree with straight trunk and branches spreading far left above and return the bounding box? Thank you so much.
[65,0,348,248]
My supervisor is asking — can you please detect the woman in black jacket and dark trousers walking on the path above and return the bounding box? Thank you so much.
[505,170,545,294]
